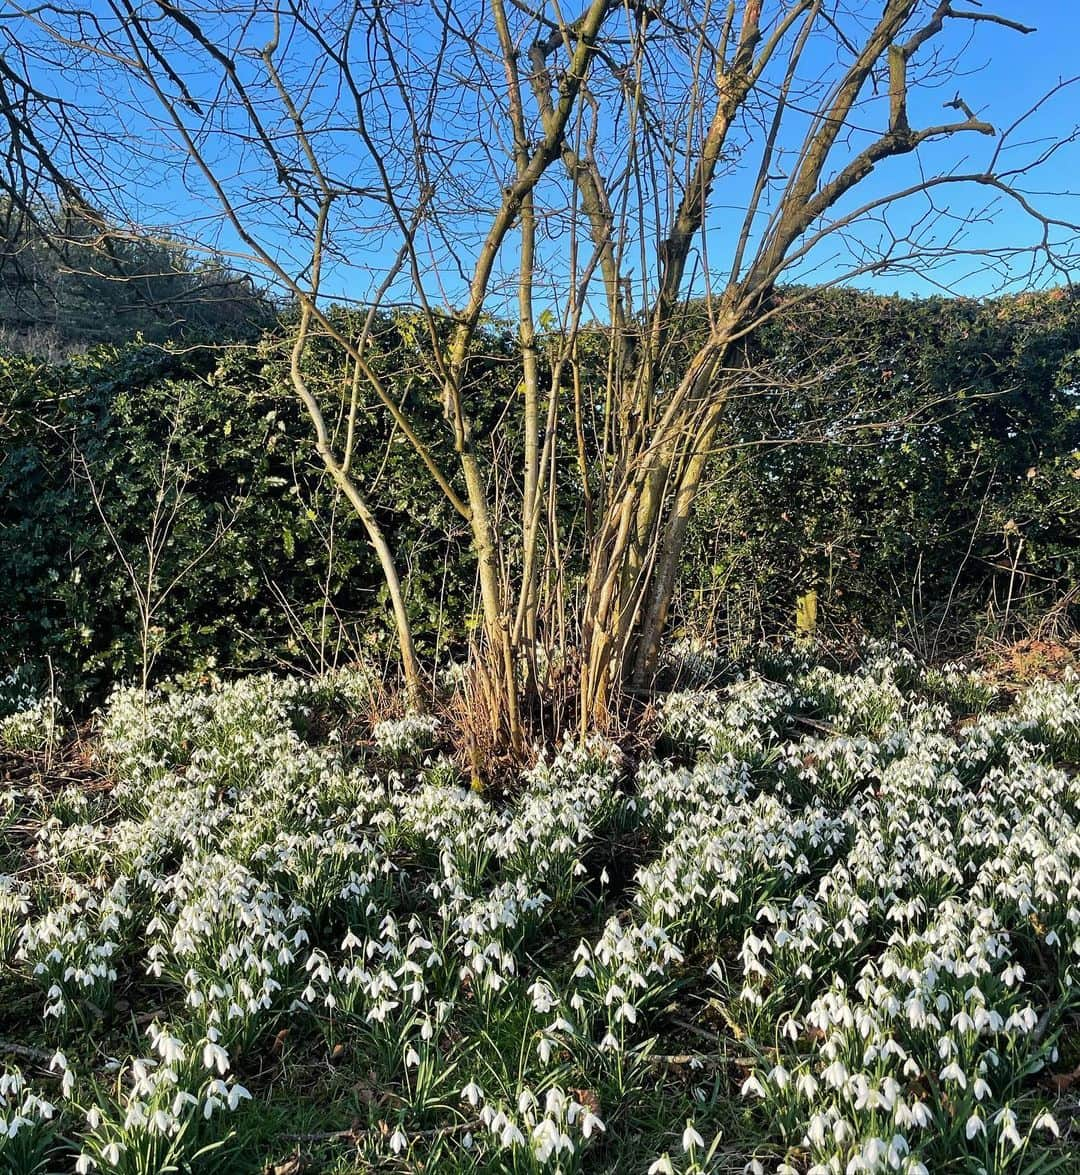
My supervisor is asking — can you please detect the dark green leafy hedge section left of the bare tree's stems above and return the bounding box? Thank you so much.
[0,329,463,701]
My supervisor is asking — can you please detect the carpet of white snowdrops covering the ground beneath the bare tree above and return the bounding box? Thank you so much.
[0,649,1080,1175]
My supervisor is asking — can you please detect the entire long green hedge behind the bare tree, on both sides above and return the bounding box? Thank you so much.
[0,291,1080,703]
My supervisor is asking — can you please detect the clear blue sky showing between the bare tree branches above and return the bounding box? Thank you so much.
[16,0,1080,314]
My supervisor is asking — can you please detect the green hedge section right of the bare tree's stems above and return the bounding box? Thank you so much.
[682,290,1080,653]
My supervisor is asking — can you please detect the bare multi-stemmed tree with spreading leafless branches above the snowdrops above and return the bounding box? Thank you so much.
[0,0,1076,747]
